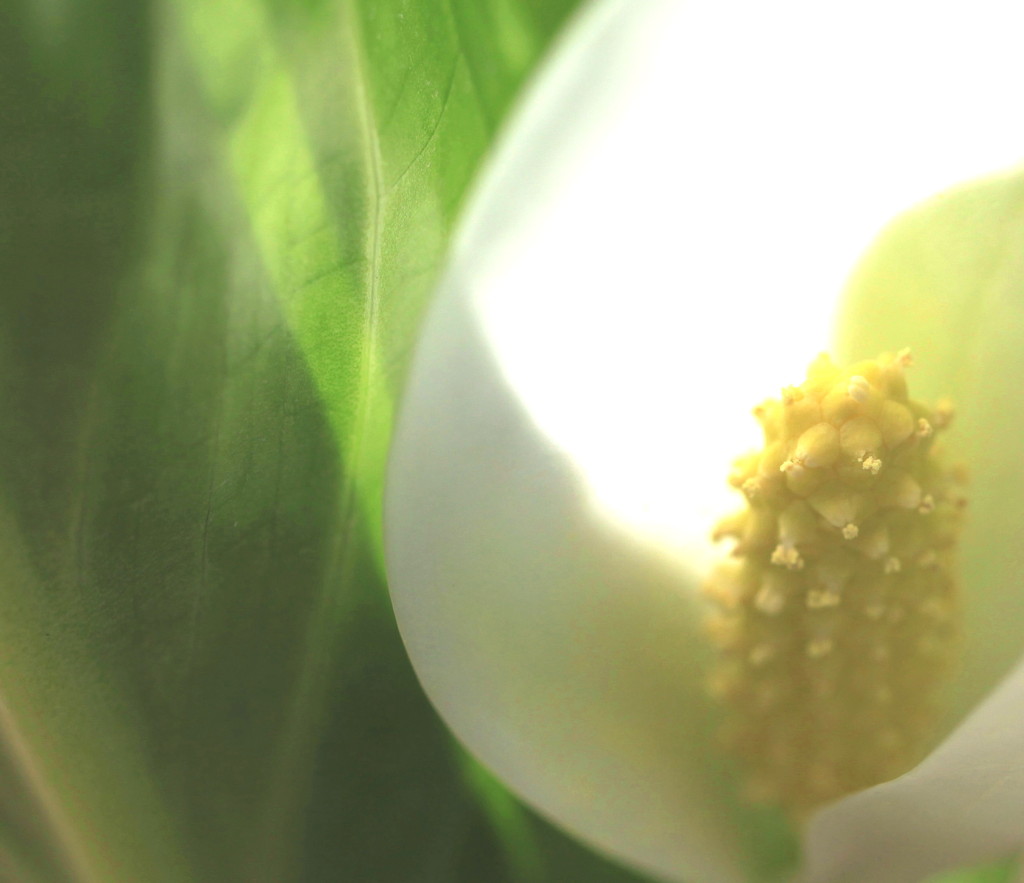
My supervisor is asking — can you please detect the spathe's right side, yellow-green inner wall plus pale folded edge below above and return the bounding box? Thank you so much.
[809,163,1024,883]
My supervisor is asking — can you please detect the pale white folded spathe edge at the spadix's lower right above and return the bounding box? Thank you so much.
[806,665,1024,883]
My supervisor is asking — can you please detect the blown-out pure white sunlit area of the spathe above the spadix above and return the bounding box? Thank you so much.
[467,0,1024,559]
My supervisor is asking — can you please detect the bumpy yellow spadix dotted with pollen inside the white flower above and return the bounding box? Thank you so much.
[708,351,966,816]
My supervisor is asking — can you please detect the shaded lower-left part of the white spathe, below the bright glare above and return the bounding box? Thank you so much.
[387,282,757,883]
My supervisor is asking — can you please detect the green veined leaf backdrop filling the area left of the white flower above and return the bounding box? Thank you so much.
[0,0,617,883]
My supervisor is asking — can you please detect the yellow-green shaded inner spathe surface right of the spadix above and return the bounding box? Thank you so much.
[837,172,1024,731]
